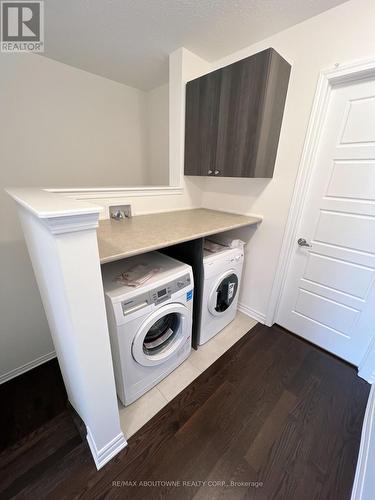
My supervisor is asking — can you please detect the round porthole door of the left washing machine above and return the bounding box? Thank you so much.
[132,304,191,366]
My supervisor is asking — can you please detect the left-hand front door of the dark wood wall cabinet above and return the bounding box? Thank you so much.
[185,70,221,175]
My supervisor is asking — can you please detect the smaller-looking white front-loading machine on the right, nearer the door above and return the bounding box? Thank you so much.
[198,244,244,345]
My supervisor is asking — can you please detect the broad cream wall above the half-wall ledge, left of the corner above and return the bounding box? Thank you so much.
[0,54,154,186]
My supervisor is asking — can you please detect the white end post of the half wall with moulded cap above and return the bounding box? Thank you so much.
[6,188,127,469]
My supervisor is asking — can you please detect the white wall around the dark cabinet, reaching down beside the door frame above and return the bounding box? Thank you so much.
[194,0,375,317]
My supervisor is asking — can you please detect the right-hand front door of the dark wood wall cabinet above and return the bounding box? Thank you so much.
[214,50,271,177]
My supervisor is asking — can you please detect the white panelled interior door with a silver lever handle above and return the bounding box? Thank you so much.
[276,76,375,366]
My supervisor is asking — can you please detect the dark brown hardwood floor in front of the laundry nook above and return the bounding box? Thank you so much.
[0,325,369,500]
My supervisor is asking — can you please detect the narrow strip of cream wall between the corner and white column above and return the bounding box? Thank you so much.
[146,84,169,186]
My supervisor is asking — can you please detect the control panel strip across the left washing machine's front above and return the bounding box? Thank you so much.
[121,273,191,316]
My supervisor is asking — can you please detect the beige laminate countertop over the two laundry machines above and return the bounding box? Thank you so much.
[97,208,262,264]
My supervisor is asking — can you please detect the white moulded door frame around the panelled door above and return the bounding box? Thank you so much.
[265,58,375,383]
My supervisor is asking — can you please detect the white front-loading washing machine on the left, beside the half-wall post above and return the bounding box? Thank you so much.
[102,252,193,406]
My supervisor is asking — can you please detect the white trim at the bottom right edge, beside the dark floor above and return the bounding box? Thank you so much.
[351,386,375,500]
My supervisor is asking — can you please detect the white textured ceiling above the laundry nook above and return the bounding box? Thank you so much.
[44,0,344,90]
